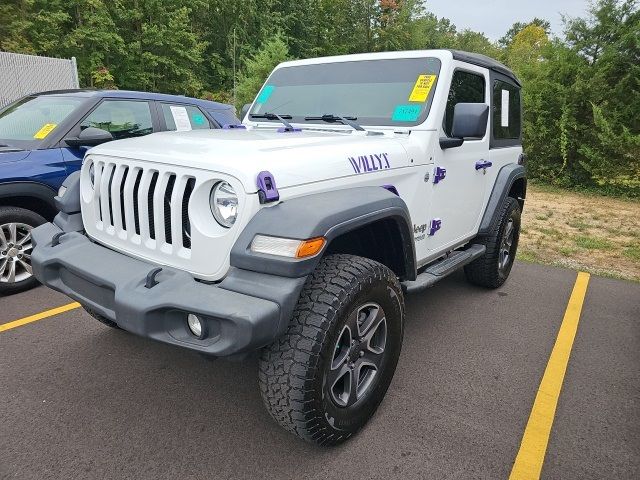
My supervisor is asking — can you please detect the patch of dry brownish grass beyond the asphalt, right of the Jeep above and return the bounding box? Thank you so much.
[518,184,640,281]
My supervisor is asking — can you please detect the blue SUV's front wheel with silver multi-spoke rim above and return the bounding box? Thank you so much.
[0,207,46,295]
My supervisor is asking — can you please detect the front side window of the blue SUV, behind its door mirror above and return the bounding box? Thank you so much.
[80,100,153,140]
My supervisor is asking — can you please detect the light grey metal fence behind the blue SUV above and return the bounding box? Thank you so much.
[0,52,78,108]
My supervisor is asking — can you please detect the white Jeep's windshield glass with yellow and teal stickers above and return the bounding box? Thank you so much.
[250,58,440,127]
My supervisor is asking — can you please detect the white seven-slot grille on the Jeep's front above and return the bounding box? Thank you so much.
[92,161,195,253]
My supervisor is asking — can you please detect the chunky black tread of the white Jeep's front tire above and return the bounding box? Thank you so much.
[259,255,404,445]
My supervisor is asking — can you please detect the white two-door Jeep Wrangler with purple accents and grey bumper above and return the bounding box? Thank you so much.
[33,50,526,445]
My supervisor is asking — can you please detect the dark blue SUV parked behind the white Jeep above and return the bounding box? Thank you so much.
[0,90,239,295]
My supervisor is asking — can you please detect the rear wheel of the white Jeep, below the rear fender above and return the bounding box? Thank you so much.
[464,197,521,288]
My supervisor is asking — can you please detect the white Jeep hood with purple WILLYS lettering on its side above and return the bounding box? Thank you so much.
[88,128,408,193]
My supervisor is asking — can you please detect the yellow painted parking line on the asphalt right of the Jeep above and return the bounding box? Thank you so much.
[509,272,589,480]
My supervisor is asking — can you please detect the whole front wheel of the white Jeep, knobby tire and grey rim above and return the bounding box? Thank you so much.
[259,255,404,446]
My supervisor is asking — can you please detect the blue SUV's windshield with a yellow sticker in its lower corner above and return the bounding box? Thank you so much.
[0,95,84,149]
